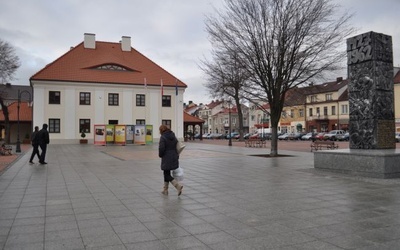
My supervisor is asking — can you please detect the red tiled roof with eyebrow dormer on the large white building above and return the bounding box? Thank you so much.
[30,41,187,88]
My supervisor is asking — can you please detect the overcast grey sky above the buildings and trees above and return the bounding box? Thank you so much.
[0,0,400,103]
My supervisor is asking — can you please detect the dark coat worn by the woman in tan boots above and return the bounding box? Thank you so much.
[158,131,179,170]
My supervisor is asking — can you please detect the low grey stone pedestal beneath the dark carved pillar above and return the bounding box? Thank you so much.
[314,149,400,179]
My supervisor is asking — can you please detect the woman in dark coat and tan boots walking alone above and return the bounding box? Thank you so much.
[158,125,183,196]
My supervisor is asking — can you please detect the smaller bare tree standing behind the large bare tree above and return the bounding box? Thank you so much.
[200,50,249,140]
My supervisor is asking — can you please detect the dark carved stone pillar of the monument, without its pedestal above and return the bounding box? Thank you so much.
[347,32,396,149]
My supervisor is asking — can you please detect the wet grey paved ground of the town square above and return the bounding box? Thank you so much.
[0,142,400,250]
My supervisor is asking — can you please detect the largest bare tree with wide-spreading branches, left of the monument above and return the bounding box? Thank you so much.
[206,0,354,156]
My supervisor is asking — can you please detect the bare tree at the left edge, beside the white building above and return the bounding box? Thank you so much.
[0,39,20,143]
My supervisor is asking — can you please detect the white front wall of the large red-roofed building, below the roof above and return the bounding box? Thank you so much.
[32,81,184,143]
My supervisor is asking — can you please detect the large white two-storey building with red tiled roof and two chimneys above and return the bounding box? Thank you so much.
[30,33,187,143]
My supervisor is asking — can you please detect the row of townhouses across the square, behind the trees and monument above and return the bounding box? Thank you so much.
[188,68,400,137]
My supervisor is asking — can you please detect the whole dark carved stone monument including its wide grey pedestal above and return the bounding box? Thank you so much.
[314,32,400,178]
